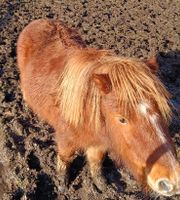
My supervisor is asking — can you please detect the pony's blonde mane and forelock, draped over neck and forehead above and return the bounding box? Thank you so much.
[58,49,171,128]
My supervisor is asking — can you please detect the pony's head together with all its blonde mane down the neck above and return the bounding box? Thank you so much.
[59,51,180,196]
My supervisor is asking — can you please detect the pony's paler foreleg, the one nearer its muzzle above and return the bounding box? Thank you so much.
[86,147,106,191]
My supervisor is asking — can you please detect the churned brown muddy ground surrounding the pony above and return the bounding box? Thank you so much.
[0,0,180,200]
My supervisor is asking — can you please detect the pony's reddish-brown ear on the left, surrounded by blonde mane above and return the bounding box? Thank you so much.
[92,74,112,94]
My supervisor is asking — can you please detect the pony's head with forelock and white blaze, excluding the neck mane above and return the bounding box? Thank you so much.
[94,55,180,196]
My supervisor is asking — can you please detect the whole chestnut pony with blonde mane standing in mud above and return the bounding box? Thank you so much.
[17,19,180,196]
